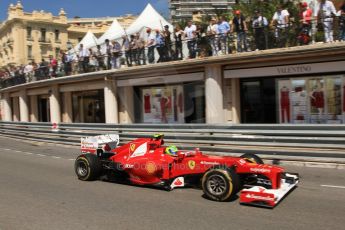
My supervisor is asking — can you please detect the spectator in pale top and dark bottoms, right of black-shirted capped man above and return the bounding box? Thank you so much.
[252,10,268,50]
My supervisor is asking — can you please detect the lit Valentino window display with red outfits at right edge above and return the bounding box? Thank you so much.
[277,76,345,124]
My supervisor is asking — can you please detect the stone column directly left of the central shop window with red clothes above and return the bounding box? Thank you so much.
[118,86,134,124]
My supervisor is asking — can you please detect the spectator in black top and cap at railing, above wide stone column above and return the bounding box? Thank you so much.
[231,10,248,53]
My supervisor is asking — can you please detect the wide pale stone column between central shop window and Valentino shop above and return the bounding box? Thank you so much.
[205,65,224,124]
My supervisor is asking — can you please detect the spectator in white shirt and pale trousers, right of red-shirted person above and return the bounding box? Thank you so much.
[314,0,337,42]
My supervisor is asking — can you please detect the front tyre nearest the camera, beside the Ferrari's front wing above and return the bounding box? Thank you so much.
[201,168,240,201]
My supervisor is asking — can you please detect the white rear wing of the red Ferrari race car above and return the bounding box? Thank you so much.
[80,134,120,154]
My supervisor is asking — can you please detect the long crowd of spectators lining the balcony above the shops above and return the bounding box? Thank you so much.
[0,0,345,87]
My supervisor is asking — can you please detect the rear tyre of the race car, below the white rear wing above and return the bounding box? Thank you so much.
[74,154,102,181]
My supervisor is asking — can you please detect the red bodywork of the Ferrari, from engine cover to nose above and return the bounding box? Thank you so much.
[101,138,284,189]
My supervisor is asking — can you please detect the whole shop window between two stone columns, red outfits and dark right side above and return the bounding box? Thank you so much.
[135,83,205,123]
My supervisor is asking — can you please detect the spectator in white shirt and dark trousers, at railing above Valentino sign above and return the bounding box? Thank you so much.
[271,5,290,48]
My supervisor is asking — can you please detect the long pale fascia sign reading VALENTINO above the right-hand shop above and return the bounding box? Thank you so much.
[224,61,345,78]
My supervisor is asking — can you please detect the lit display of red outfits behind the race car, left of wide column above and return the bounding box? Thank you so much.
[142,86,184,123]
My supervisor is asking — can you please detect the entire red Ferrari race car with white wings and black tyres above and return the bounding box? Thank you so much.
[75,134,299,208]
